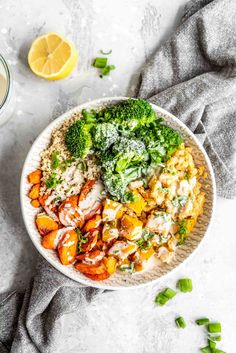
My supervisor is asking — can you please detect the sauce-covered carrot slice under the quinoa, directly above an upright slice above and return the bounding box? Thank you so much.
[58,195,84,228]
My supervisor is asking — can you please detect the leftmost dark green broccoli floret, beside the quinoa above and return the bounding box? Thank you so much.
[65,120,92,158]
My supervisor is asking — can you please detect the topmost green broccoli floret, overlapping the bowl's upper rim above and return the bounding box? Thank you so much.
[98,98,156,130]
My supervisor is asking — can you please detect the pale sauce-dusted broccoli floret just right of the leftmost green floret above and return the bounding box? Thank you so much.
[92,123,119,151]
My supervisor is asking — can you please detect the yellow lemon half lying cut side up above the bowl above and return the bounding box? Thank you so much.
[28,32,78,80]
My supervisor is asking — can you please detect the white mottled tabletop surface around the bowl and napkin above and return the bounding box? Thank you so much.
[0,0,236,353]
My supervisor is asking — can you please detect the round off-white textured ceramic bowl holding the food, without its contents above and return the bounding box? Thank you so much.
[20,97,215,289]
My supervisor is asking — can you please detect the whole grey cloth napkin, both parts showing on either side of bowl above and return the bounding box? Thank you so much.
[0,0,236,353]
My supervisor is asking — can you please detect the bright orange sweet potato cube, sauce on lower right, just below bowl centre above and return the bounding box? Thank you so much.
[120,214,143,240]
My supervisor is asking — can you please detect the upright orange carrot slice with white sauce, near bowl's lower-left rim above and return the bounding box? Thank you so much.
[57,230,78,265]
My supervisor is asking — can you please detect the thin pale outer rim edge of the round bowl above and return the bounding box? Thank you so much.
[20,96,216,290]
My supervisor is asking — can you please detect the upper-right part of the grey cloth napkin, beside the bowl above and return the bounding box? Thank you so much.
[138,0,236,198]
